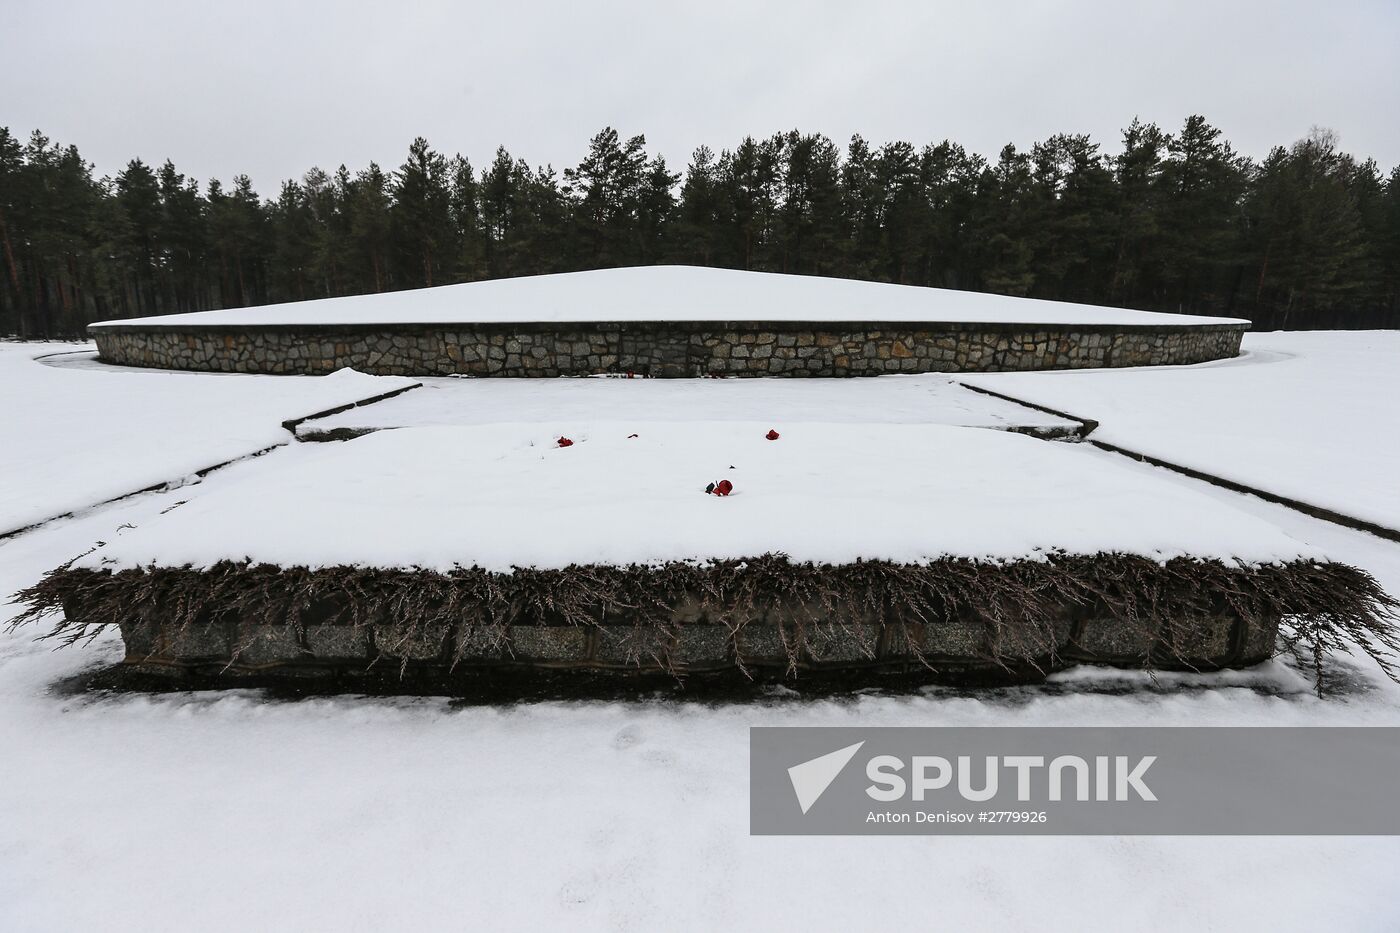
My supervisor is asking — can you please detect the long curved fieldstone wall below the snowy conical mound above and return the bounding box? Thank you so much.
[91,321,1247,377]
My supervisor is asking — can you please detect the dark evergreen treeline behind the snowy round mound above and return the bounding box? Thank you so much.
[0,116,1400,336]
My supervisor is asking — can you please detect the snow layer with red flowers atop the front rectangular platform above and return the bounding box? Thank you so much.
[84,422,1320,572]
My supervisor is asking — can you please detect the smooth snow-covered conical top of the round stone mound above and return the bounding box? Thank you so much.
[90,266,1247,331]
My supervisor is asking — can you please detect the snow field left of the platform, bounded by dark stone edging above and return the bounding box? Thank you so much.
[0,342,413,534]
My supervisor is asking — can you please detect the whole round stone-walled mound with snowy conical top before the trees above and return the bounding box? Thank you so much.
[88,266,1249,377]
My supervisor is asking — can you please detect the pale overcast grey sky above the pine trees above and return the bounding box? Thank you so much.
[0,0,1400,195]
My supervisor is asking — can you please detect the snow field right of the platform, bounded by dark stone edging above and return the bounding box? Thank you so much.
[958,331,1400,530]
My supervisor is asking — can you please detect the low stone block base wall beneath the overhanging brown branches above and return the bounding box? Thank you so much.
[122,615,1278,682]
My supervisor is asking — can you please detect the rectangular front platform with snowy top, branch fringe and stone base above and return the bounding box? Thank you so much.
[13,422,1379,682]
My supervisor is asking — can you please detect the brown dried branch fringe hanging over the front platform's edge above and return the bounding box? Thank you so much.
[11,553,1400,692]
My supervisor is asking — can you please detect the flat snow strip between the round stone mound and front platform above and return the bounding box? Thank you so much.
[297,375,1078,436]
